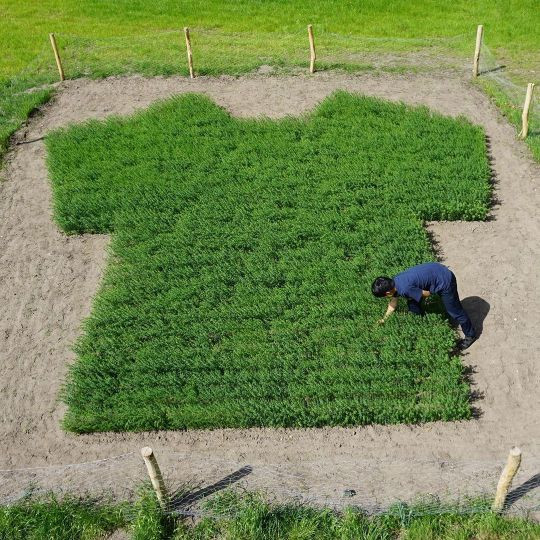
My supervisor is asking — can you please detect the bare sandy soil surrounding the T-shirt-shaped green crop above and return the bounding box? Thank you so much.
[0,73,540,503]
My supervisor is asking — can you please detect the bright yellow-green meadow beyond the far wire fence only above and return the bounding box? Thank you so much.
[0,0,540,77]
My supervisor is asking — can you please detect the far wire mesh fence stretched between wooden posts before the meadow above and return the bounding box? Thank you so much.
[0,28,528,82]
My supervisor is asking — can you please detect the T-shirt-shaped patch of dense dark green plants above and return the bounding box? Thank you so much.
[47,92,490,432]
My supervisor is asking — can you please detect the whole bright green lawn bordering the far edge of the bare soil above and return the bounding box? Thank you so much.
[0,0,540,159]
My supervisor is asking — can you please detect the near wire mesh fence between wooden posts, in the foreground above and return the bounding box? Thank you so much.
[0,452,540,518]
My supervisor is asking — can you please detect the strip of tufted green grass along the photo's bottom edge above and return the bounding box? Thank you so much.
[0,492,540,540]
